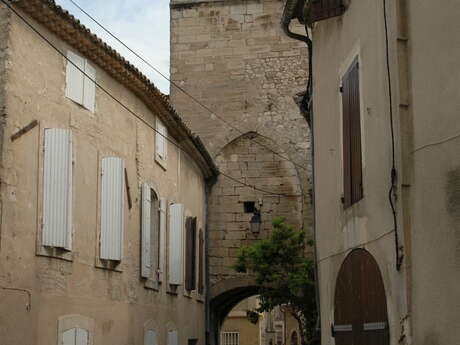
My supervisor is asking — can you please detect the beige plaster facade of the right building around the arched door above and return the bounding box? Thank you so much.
[298,0,460,345]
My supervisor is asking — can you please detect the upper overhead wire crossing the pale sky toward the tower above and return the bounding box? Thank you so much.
[63,0,308,170]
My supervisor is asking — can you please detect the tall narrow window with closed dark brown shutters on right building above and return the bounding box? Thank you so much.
[341,59,363,208]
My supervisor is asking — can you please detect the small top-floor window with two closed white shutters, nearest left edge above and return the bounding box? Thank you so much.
[65,51,96,112]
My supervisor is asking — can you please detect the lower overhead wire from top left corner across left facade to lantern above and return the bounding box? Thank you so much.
[0,0,303,197]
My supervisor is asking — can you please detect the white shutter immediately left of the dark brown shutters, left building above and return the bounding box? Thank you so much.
[169,204,184,285]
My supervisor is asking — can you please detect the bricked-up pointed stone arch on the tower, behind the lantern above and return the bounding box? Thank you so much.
[207,132,309,344]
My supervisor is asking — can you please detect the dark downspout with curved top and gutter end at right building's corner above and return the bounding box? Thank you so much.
[281,4,321,343]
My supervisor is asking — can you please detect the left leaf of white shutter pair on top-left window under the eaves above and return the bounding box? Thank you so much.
[65,51,85,104]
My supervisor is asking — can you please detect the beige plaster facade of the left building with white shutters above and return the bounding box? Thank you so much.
[0,2,216,345]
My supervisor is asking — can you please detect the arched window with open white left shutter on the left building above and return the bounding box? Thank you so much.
[141,183,160,281]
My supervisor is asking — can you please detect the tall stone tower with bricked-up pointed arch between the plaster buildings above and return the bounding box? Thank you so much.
[171,0,312,340]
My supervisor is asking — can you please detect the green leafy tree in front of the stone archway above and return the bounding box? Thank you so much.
[233,217,317,345]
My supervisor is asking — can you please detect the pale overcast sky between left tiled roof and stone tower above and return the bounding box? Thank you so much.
[56,0,169,94]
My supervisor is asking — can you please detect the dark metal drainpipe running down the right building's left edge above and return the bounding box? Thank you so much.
[282,19,321,342]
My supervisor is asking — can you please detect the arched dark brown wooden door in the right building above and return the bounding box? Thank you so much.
[332,249,390,345]
